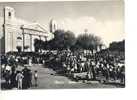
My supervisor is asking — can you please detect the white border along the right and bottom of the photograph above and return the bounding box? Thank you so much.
[0,0,137,100]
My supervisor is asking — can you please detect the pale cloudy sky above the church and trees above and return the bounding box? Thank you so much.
[0,0,125,46]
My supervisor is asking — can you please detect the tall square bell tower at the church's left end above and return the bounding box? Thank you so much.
[3,6,16,53]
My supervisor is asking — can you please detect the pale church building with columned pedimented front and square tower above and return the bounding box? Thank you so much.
[0,7,53,53]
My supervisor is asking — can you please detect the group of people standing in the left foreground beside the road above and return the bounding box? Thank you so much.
[1,56,38,89]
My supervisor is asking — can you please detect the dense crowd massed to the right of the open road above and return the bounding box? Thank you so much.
[45,50,125,84]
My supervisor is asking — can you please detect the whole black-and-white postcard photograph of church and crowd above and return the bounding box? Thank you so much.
[0,0,126,90]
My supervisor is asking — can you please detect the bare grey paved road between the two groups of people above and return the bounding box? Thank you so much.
[26,65,120,89]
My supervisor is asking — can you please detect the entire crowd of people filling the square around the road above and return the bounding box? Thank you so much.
[1,50,125,89]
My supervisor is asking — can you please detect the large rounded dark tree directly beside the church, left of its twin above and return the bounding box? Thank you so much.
[48,30,76,50]
